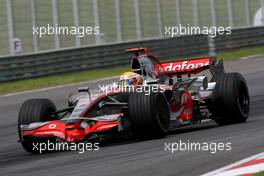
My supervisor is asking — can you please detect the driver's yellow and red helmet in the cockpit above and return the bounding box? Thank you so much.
[119,72,144,87]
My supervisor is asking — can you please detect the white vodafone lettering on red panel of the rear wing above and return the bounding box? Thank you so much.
[162,58,209,73]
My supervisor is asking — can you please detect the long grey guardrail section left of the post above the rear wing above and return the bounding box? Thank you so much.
[0,35,208,82]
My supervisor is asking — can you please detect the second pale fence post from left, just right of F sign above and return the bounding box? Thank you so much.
[30,0,38,52]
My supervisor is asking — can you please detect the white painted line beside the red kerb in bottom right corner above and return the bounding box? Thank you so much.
[201,152,264,176]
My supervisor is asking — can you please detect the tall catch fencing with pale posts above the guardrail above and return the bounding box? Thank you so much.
[0,0,264,56]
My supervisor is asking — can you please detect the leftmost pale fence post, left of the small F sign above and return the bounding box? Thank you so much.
[6,0,14,56]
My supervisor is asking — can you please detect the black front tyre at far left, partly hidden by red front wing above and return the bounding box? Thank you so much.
[18,99,57,153]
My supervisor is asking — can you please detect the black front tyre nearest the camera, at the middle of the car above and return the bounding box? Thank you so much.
[128,92,170,139]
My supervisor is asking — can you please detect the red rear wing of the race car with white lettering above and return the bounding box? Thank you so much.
[159,57,216,76]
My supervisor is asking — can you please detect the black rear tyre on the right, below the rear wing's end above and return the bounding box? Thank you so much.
[209,73,250,125]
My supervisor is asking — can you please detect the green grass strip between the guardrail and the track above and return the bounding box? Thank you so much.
[0,47,264,95]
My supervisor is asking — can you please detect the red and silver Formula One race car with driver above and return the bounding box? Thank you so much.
[18,48,250,153]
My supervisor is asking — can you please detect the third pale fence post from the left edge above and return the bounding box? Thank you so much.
[52,0,60,49]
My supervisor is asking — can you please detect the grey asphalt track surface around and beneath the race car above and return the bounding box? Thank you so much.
[0,58,264,176]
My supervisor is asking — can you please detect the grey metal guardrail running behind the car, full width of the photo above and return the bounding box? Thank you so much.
[0,27,264,82]
